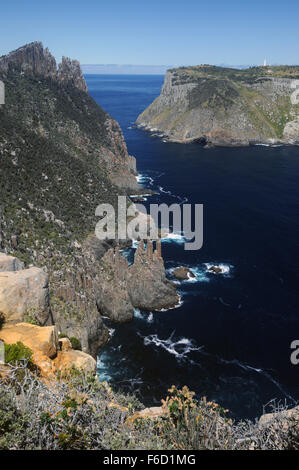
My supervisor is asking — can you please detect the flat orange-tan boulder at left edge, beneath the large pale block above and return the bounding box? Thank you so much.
[0,323,58,358]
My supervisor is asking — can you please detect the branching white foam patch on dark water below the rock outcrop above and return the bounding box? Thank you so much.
[143,332,202,359]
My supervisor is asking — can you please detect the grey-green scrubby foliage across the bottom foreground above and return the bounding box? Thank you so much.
[0,365,299,450]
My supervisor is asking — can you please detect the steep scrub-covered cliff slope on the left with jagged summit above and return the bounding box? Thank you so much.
[0,43,139,352]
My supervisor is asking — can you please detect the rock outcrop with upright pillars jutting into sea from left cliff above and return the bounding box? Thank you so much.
[95,241,179,322]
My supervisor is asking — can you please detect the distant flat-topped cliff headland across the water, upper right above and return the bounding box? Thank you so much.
[137,66,299,145]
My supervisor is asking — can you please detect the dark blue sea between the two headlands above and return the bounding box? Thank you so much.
[86,75,299,418]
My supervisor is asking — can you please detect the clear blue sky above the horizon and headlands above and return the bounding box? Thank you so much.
[0,0,299,65]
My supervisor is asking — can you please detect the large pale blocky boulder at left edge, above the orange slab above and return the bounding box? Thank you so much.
[0,268,49,324]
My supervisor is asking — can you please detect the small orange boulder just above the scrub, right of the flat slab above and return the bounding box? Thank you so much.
[53,349,97,375]
